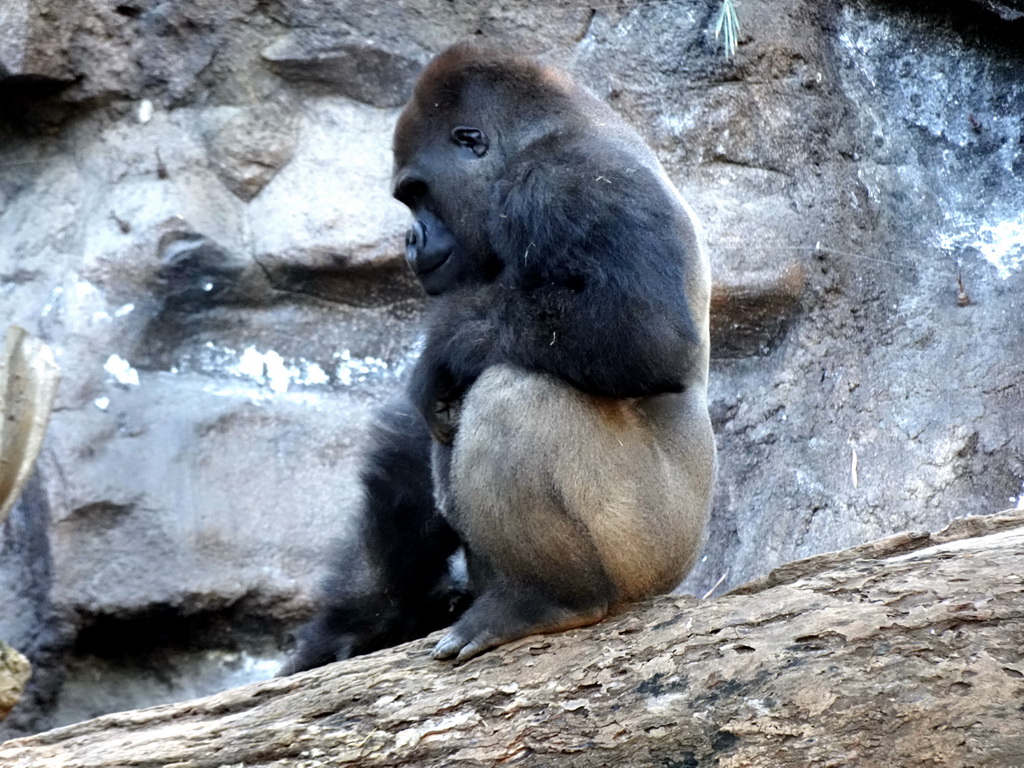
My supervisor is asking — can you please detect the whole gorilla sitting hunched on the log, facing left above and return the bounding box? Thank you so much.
[283,44,716,674]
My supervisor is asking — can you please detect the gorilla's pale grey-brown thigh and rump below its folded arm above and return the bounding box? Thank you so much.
[450,366,714,602]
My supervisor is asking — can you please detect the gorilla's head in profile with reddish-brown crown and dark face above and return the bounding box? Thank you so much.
[392,44,574,295]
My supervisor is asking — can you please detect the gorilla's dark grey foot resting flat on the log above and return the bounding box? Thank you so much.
[432,592,608,662]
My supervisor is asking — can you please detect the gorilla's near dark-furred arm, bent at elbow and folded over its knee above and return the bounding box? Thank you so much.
[411,158,700,434]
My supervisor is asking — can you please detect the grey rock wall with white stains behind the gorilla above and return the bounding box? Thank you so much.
[0,0,1024,739]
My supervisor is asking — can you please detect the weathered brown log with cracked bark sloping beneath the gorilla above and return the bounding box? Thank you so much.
[0,512,1024,768]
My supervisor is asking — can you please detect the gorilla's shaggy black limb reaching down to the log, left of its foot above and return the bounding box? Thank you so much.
[282,399,468,675]
